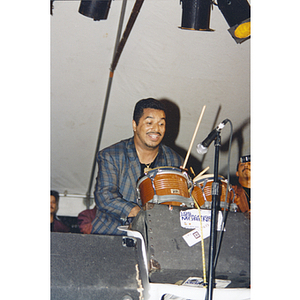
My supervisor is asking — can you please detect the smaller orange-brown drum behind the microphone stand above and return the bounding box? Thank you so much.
[192,174,234,209]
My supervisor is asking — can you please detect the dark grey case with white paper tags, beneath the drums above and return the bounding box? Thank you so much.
[132,203,250,288]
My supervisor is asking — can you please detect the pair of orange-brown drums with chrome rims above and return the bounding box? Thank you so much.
[137,167,235,210]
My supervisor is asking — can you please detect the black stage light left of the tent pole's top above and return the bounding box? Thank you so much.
[78,0,111,21]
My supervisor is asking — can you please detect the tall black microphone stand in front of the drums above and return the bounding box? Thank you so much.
[205,131,221,300]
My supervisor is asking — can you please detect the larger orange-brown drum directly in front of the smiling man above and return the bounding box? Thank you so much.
[137,167,193,207]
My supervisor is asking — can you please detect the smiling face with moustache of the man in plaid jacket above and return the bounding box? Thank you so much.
[132,108,166,149]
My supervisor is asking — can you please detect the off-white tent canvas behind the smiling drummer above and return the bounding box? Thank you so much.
[51,0,250,195]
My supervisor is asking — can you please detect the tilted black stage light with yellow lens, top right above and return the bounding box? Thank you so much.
[218,0,251,44]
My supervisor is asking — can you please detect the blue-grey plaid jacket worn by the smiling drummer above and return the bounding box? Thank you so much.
[91,137,183,235]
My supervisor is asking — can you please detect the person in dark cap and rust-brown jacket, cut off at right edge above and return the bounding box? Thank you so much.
[232,155,251,214]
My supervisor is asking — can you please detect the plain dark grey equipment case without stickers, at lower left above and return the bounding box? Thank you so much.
[51,232,145,300]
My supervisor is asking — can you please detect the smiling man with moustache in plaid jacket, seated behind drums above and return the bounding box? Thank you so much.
[92,98,183,235]
